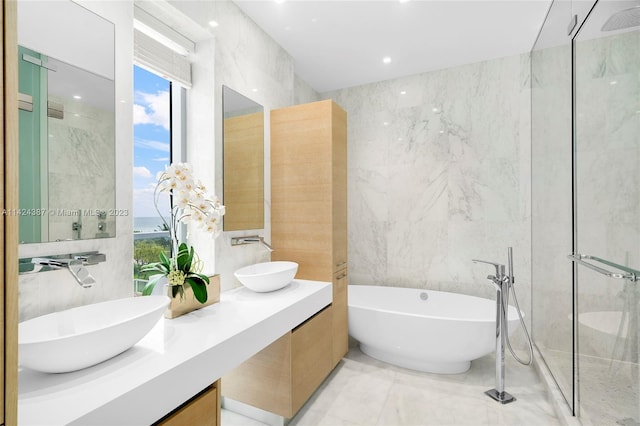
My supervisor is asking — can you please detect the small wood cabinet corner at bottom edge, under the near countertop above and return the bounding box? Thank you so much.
[156,380,222,426]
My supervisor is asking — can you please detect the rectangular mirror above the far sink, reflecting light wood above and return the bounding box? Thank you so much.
[222,86,264,231]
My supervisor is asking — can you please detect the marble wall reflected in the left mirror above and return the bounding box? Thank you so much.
[48,97,116,241]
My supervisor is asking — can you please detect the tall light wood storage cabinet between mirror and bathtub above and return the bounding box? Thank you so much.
[271,100,348,366]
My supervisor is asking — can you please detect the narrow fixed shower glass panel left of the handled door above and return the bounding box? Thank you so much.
[531,1,574,409]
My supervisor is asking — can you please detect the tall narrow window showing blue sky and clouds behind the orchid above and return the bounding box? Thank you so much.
[133,66,172,292]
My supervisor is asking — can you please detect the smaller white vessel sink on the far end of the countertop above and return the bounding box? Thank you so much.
[234,261,298,293]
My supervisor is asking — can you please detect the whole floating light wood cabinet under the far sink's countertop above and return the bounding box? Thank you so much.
[222,306,333,418]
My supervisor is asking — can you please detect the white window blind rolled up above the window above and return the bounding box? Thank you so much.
[133,29,191,87]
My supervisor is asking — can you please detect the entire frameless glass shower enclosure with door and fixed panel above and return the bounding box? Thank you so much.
[531,0,640,425]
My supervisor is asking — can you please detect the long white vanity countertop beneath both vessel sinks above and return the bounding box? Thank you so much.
[18,280,332,426]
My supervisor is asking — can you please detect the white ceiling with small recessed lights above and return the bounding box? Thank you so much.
[233,0,551,92]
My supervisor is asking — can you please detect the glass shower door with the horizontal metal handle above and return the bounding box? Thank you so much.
[573,1,640,425]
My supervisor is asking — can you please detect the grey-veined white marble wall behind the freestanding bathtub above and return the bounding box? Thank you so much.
[322,54,531,332]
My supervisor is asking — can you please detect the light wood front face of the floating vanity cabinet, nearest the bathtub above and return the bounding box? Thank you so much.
[291,306,333,413]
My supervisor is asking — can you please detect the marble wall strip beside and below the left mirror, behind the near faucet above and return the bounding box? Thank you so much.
[19,0,133,321]
